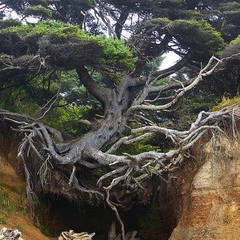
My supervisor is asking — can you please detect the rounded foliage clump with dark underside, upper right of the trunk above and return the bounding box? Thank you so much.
[135,18,225,62]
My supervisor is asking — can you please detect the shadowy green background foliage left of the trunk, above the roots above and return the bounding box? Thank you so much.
[0,66,100,136]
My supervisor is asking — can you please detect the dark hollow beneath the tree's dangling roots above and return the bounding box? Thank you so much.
[37,188,179,240]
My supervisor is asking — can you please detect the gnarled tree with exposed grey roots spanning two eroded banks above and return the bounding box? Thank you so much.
[0,0,239,239]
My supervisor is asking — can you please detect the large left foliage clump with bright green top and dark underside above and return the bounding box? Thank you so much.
[0,21,135,71]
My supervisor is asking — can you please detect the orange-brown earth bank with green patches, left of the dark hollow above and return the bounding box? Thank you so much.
[0,157,54,240]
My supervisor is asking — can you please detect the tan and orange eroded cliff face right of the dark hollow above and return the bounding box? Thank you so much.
[169,136,240,240]
